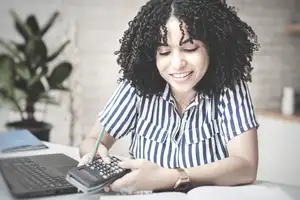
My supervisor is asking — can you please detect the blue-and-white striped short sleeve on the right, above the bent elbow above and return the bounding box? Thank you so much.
[218,81,259,142]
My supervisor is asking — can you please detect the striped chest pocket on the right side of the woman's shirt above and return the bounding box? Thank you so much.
[184,119,220,144]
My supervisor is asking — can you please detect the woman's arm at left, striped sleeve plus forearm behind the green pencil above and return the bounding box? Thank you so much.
[80,81,137,156]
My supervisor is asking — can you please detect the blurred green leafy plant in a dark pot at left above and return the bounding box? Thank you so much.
[0,10,73,141]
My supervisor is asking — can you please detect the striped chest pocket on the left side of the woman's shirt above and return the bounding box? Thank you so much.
[136,118,168,143]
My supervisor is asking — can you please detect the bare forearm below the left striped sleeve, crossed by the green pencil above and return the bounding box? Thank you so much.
[79,120,116,157]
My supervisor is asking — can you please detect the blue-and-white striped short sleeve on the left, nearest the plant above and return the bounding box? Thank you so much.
[99,81,137,139]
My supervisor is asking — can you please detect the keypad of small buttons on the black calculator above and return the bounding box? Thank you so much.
[87,156,125,179]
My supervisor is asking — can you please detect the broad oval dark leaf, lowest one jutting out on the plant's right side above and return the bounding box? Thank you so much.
[48,62,73,88]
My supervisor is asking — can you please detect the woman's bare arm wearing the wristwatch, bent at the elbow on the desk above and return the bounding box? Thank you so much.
[161,128,258,188]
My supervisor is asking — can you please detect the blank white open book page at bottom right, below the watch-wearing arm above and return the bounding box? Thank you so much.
[187,184,293,200]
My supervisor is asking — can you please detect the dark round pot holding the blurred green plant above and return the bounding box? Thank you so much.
[6,121,53,142]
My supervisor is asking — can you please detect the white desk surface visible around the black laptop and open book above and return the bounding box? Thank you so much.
[0,142,300,200]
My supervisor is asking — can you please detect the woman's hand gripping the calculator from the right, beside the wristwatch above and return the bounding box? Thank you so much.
[105,159,176,194]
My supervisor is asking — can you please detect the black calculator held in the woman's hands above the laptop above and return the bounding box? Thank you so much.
[66,156,131,193]
